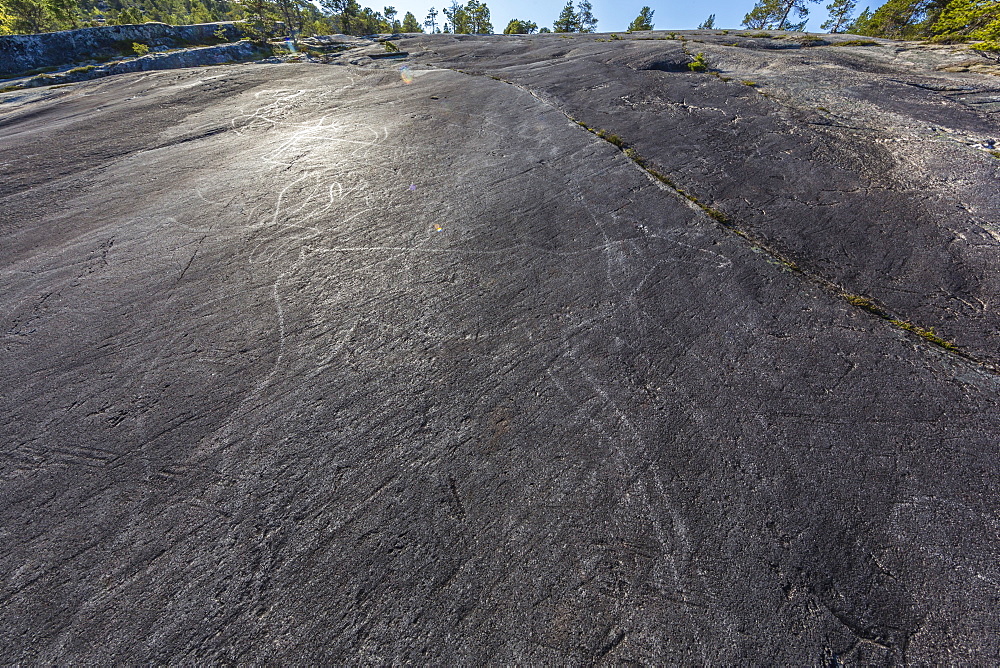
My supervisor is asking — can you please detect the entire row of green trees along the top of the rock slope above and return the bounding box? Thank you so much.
[0,0,1000,52]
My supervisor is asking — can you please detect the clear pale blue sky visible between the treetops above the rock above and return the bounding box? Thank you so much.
[386,0,848,32]
